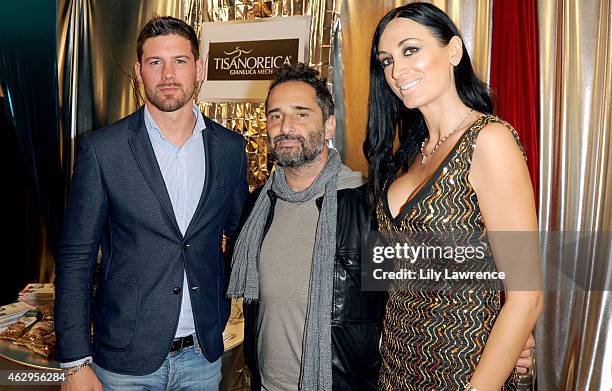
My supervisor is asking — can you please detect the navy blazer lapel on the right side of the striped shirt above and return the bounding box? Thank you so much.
[185,117,219,236]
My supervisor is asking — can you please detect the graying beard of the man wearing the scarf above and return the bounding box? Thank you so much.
[269,129,325,167]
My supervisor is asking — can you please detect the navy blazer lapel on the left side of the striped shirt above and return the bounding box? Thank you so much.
[128,109,182,237]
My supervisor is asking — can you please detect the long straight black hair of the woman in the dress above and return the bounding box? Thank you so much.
[363,3,493,207]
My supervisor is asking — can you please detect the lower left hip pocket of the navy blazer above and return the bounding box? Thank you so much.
[93,280,140,350]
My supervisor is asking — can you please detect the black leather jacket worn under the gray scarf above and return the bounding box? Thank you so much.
[244,185,385,391]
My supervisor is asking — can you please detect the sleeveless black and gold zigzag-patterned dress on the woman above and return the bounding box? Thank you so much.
[376,115,522,391]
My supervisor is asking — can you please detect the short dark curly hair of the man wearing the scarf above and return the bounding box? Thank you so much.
[266,62,334,121]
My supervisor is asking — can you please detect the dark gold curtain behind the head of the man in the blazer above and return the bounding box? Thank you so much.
[57,0,182,176]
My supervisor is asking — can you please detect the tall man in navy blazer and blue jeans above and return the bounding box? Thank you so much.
[55,17,248,391]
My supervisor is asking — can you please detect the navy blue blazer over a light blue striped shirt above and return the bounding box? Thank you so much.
[55,109,248,375]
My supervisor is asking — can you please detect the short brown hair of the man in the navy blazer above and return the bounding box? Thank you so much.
[136,15,200,62]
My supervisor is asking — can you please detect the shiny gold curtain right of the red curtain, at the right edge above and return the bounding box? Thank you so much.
[536,0,612,391]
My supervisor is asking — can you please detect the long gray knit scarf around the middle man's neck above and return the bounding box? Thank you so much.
[227,149,341,391]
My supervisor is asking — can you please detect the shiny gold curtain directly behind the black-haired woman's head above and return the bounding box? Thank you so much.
[336,0,493,173]
